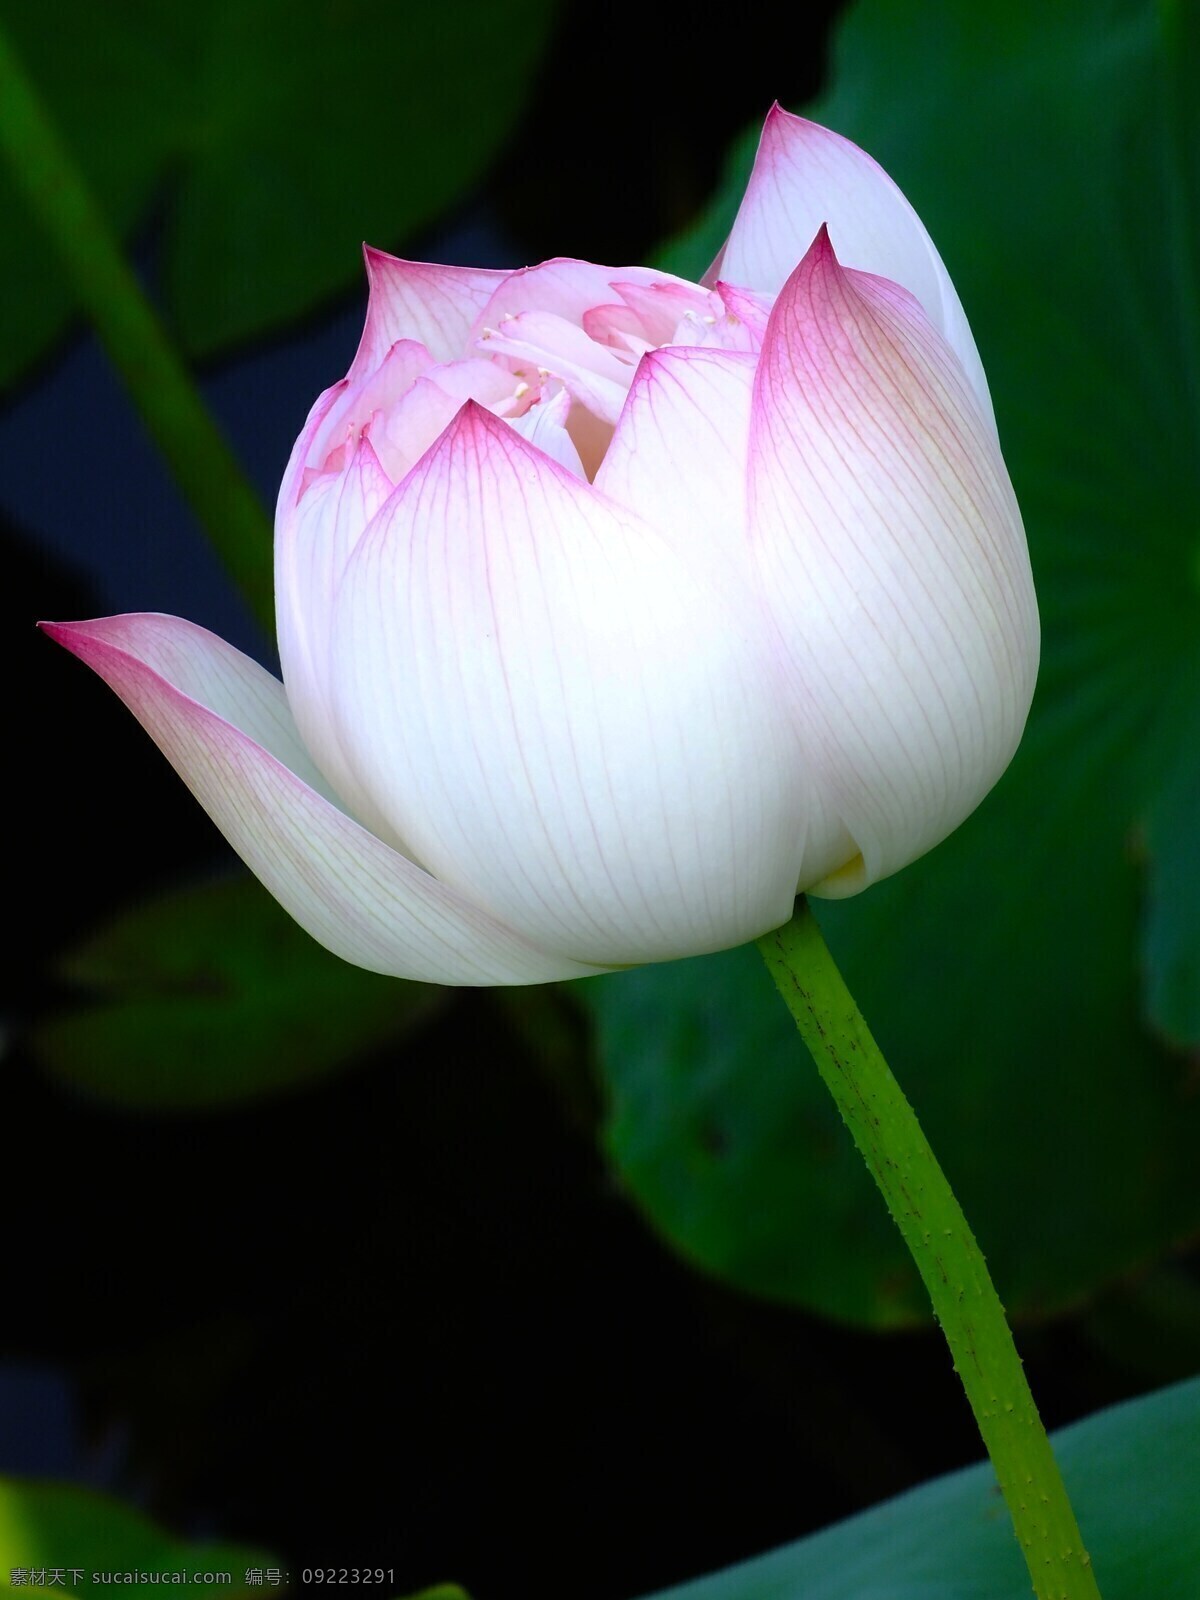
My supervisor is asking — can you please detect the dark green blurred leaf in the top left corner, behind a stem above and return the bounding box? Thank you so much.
[0,0,557,384]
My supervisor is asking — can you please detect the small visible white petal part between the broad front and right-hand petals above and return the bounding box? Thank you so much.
[595,347,755,581]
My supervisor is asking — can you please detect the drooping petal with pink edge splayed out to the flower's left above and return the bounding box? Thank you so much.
[43,616,611,984]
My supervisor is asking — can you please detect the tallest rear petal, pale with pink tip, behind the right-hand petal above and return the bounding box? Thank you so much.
[720,106,995,426]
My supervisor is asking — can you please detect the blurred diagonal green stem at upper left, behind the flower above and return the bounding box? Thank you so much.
[0,27,274,637]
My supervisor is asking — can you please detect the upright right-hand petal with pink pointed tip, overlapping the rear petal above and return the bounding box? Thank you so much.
[750,230,1038,893]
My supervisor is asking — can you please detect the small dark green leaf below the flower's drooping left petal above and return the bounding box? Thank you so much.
[32,877,443,1109]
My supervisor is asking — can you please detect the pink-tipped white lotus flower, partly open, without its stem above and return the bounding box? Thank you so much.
[48,109,1038,984]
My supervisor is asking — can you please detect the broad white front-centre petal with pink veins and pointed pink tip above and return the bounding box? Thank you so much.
[334,405,805,963]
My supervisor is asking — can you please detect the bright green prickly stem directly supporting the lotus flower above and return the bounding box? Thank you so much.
[758,899,1099,1600]
